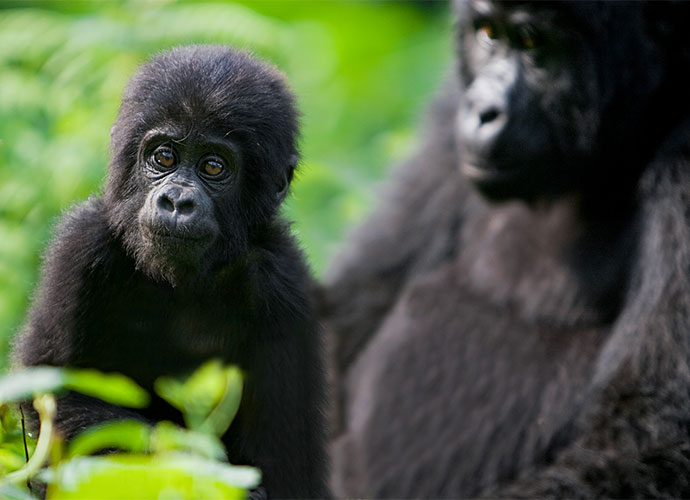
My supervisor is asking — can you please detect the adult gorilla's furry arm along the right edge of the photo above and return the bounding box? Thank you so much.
[489,125,690,498]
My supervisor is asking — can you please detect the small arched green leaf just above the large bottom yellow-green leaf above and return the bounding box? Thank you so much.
[67,420,151,458]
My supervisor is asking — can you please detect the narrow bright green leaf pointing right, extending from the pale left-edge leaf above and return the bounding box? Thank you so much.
[64,369,150,408]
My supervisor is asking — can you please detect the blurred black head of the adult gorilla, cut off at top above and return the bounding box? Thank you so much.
[457,0,687,200]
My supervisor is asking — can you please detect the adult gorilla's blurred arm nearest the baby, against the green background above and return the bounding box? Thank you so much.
[319,79,466,369]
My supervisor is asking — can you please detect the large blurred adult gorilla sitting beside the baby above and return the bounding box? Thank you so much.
[322,1,690,498]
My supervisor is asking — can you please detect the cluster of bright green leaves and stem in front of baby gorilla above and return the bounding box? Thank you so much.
[0,361,260,499]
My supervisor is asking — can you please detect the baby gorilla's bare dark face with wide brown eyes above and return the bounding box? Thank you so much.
[136,129,228,282]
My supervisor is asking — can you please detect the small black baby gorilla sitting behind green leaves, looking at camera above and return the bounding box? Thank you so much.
[14,46,327,498]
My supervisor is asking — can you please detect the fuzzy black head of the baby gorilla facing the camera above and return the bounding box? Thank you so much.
[105,46,298,285]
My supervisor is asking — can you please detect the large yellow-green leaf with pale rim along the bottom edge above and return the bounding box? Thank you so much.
[42,453,261,500]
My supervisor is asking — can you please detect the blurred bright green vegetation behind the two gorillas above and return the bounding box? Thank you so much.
[0,0,452,372]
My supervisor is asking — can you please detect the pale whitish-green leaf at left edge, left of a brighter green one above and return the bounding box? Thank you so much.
[0,366,65,404]
